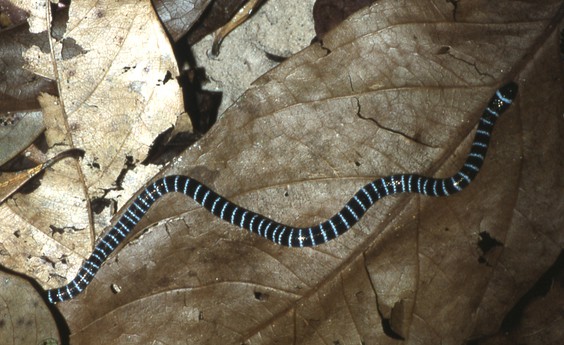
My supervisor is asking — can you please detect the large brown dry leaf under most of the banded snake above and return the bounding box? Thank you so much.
[32,1,564,344]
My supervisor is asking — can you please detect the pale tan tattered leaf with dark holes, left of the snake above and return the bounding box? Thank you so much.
[0,0,185,306]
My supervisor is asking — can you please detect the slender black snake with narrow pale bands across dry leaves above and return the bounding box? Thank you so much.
[47,82,518,303]
